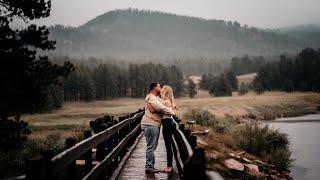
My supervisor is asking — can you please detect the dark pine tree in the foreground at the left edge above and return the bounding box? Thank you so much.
[0,0,73,148]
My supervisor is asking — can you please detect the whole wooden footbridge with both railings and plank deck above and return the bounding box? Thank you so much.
[24,110,222,180]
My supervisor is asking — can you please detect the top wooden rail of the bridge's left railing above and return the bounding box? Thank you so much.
[50,112,144,174]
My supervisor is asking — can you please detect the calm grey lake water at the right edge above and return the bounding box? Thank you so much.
[267,114,320,180]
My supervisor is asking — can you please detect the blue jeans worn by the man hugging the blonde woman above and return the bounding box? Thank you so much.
[141,124,160,170]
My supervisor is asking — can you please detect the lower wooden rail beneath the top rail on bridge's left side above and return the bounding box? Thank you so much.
[83,125,141,180]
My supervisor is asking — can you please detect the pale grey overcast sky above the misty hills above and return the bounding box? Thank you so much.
[36,0,320,28]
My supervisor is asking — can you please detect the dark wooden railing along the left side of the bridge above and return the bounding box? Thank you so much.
[26,110,144,180]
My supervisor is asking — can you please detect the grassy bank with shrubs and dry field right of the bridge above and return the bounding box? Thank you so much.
[182,92,320,179]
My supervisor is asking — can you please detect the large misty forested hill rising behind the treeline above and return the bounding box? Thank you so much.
[50,9,314,59]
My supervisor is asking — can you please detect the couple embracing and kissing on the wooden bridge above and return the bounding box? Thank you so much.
[141,83,177,174]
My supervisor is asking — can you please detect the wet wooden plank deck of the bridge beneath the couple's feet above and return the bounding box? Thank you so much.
[117,129,179,180]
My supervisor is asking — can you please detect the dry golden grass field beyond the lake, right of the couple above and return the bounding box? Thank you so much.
[177,91,320,120]
